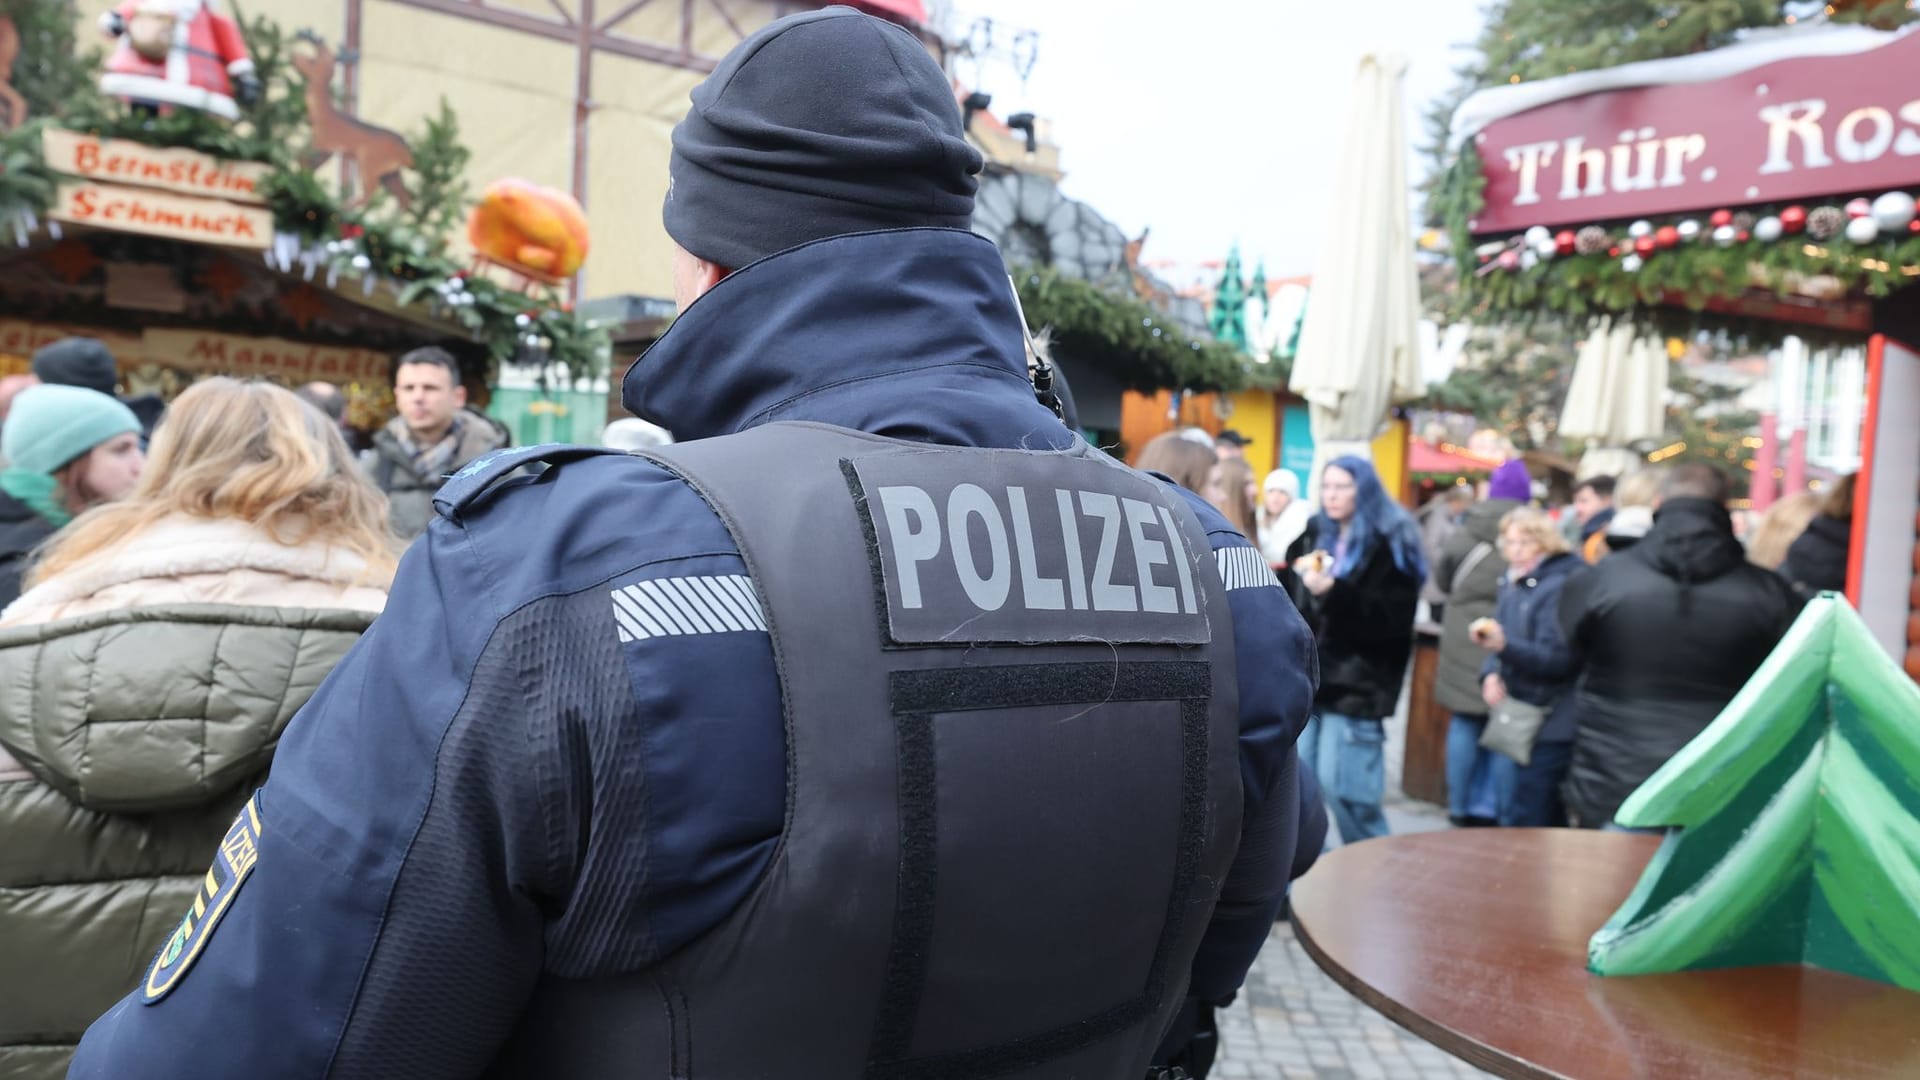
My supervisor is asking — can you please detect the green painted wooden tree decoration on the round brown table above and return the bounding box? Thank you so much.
[1588,594,1920,990]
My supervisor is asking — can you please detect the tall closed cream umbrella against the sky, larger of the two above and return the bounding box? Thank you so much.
[1290,54,1423,490]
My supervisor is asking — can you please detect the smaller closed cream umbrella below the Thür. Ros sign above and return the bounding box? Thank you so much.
[1559,317,1667,479]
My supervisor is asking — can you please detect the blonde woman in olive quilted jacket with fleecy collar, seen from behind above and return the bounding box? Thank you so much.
[0,379,396,1076]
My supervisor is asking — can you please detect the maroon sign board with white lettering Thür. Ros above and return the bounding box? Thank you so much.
[1473,35,1920,233]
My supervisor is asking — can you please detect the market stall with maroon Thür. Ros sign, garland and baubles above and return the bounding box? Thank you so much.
[1442,25,1920,676]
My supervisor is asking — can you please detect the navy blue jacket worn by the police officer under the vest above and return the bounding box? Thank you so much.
[71,231,1325,1080]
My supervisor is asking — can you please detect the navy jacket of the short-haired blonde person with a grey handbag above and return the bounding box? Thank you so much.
[1480,555,1586,742]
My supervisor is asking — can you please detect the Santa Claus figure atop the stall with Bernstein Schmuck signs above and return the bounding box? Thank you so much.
[100,0,259,119]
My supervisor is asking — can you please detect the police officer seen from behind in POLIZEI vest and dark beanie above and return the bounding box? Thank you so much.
[73,8,1325,1080]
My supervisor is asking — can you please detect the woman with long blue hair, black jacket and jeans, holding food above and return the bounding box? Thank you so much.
[1288,457,1427,844]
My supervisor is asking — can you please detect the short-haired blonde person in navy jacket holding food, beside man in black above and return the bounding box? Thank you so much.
[1473,509,1586,828]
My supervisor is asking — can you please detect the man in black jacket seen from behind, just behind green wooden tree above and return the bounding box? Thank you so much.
[1559,463,1801,826]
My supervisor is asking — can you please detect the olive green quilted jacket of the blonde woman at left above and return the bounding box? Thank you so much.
[0,603,372,1080]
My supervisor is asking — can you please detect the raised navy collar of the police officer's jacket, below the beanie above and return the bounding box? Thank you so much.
[620,229,1073,450]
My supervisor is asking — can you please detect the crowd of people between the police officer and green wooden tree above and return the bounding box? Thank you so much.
[1137,429,1855,842]
